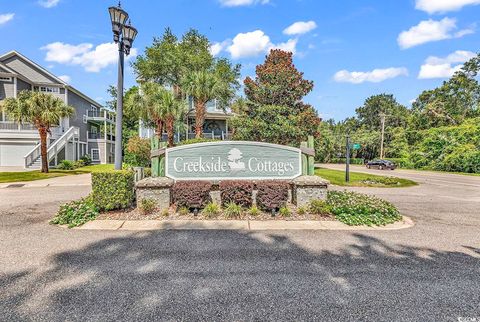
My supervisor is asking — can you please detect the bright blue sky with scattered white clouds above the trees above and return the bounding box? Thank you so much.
[0,0,480,120]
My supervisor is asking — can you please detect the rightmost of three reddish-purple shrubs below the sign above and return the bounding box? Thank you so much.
[257,181,288,211]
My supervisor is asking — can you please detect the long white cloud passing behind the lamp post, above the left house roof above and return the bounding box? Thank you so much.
[41,42,137,73]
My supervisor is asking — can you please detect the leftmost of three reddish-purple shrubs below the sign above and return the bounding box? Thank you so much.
[172,181,212,209]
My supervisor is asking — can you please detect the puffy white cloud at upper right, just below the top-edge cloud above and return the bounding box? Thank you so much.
[397,18,473,49]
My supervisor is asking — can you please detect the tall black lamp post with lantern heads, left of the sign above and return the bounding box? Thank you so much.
[108,2,137,170]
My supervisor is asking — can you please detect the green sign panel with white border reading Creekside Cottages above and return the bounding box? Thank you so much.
[165,141,302,180]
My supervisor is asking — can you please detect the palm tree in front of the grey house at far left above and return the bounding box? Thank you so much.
[2,91,75,173]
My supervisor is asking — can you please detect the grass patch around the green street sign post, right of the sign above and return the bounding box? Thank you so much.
[315,168,417,188]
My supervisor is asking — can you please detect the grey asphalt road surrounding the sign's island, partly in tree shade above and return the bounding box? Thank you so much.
[0,171,480,321]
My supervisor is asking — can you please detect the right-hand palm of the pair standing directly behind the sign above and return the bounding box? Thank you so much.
[182,70,221,138]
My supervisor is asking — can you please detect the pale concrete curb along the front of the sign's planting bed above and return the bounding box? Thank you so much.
[75,216,415,231]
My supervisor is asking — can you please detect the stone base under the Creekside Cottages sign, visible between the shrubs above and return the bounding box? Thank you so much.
[136,176,329,211]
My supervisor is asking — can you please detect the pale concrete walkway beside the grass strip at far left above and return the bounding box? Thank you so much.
[0,173,91,189]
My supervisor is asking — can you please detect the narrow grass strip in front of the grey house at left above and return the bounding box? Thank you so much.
[0,164,113,183]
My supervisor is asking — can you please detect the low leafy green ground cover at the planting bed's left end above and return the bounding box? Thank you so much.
[50,196,99,228]
